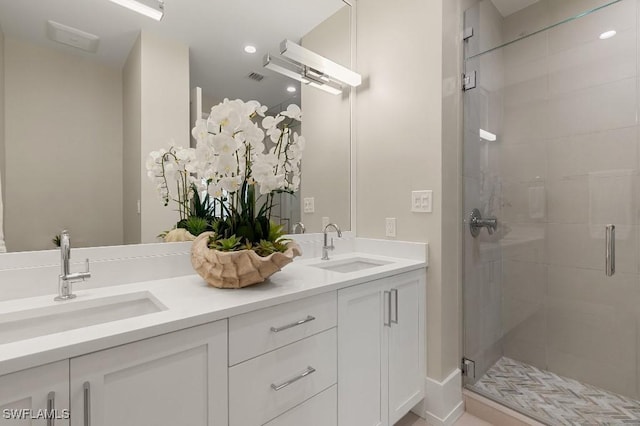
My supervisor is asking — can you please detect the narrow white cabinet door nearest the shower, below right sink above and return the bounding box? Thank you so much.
[389,273,426,424]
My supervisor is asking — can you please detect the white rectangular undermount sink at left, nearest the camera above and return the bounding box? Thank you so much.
[0,291,167,345]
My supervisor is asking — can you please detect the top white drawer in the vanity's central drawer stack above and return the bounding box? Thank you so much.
[229,291,337,365]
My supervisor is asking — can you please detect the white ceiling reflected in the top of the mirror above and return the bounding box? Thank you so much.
[0,0,348,106]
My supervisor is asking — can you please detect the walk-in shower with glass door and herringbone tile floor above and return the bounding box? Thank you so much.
[463,0,640,425]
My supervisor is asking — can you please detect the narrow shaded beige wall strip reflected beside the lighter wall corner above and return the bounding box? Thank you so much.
[122,37,143,244]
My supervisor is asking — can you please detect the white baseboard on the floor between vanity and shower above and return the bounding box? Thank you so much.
[421,369,464,426]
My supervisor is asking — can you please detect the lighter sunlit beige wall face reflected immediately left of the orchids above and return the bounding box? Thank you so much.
[140,32,191,243]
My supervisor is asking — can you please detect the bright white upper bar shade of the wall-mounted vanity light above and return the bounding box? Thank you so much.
[280,40,362,87]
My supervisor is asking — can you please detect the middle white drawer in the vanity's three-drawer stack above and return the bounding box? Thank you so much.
[229,328,337,426]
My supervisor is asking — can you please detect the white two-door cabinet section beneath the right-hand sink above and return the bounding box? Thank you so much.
[338,270,426,426]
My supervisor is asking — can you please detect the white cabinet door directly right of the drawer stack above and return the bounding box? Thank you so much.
[338,281,389,426]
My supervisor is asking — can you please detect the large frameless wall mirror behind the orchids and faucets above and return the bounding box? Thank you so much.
[0,0,353,252]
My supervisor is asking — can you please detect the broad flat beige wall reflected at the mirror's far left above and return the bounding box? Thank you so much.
[5,37,123,251]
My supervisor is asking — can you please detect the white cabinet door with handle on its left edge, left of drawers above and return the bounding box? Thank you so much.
[70,320,228,426]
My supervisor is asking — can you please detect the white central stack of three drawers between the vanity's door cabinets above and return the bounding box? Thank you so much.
[229,291,338,426]
